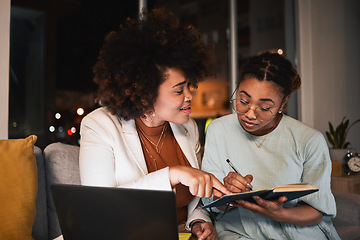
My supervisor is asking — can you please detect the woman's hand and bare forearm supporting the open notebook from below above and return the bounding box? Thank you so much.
[232,196,323,225]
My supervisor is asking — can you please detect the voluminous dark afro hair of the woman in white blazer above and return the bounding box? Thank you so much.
[93,8,213,120]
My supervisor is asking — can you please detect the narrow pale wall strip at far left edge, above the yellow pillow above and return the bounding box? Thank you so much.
[0,0,10,139]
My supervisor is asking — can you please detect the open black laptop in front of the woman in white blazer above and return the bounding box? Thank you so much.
[50,184,178,240]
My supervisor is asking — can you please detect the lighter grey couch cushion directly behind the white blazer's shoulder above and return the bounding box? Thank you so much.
[44,143,80,239]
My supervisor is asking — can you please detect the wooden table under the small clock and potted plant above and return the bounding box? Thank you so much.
[331,174,360,194]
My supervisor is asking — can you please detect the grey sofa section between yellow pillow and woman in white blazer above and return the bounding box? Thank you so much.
[33,143,80,240]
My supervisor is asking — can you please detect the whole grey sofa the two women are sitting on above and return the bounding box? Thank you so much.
[0,136,360,240]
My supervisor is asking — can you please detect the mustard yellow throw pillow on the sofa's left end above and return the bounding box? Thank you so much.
[0,135,38,240]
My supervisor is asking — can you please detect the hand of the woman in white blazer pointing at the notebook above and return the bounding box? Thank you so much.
[169,166,230,198]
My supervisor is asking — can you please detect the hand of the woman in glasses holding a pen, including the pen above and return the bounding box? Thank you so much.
[224,159,253,192]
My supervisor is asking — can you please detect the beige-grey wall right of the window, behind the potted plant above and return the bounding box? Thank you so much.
[297,0,360,151]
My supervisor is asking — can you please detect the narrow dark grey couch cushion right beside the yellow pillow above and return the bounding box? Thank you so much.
[32,146,49,240]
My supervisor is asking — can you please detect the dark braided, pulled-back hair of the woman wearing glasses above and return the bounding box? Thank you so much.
[238,52,301,97]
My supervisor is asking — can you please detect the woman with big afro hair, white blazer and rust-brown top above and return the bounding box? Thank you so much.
[79,9,229,239]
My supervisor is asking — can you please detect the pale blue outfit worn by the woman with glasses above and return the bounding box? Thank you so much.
[202,114,340,240]
